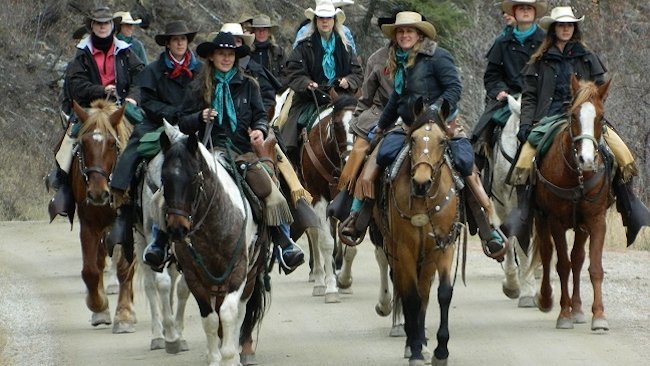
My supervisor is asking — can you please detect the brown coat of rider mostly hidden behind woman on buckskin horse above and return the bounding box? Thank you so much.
[350,45,393,138]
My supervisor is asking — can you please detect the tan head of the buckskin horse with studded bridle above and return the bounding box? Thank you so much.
[408,98,451,197]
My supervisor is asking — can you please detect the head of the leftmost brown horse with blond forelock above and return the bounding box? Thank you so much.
[73,100,130,206]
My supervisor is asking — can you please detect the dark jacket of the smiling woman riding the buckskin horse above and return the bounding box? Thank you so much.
[378,38,462,129]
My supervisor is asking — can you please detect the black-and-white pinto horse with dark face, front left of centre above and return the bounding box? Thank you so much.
[160,130,269,366]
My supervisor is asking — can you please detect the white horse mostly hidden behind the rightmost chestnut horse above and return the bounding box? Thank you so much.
[488,95,536,308]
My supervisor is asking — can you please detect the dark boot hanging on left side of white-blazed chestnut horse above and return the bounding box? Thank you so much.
[501,185,533,252]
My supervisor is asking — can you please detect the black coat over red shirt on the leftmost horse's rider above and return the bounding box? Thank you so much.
[66,36,144,108]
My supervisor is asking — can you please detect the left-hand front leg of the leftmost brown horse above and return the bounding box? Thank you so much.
[79,222,111,326]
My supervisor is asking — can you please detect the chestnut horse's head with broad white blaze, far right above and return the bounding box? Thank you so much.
[569,75,611,171]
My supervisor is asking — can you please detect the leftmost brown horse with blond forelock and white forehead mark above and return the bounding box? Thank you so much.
[70,100,136,333]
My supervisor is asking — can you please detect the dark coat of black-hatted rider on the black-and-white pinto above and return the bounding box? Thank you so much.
[178,66,268,153]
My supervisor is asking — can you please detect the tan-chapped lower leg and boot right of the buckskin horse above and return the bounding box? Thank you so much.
[465,171,508,262]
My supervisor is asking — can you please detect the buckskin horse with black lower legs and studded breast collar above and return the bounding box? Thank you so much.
[374,103,460,366]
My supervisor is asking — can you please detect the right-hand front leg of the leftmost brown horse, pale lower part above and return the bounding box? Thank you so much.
[113,249,137,334]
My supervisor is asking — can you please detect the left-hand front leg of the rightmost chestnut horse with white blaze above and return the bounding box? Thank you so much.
[549,220,573,329]
